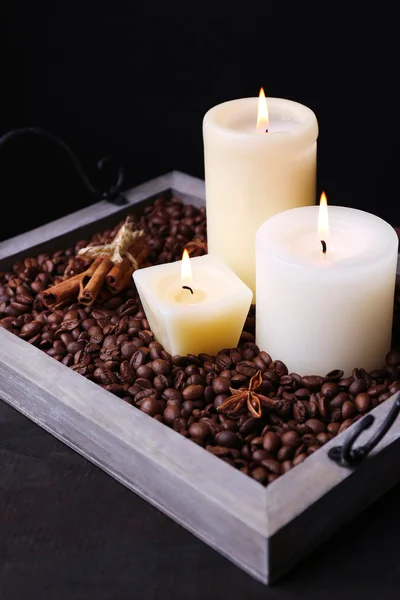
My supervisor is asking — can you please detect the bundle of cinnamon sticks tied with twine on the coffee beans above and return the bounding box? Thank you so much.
[42,221,149,309]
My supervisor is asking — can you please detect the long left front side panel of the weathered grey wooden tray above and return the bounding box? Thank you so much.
[0,330,267,579]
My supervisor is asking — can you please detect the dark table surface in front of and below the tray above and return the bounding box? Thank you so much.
[0,401,400,600]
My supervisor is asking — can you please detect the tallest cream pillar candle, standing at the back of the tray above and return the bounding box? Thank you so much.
[203,90,318,292]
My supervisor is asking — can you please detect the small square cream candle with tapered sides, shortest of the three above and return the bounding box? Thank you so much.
[133,253,252,356]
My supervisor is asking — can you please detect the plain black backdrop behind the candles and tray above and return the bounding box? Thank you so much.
[0,9,400,239]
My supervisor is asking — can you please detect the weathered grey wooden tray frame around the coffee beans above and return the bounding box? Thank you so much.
[0,172,400,583]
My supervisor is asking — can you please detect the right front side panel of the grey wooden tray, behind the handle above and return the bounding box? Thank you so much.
[266,394,400,583]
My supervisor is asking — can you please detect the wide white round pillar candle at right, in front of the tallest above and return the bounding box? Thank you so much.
[256,197,398,376]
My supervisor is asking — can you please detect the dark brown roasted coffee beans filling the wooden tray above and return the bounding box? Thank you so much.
[0,197,400,485]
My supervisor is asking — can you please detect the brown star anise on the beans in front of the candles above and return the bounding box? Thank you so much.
[217,371,279,419]
